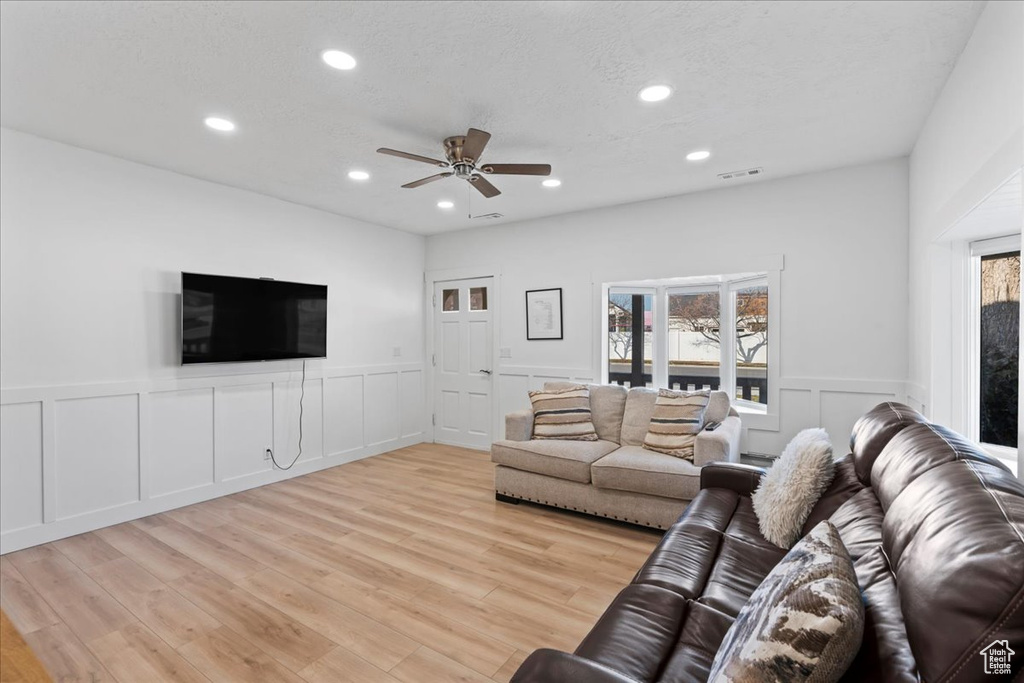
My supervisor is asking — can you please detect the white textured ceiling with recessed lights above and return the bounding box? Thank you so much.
[0,1,982,233]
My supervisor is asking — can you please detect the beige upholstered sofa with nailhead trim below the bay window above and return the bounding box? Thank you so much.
[490,382,740,529]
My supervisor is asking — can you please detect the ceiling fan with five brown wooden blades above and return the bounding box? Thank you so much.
[377,128,551,198]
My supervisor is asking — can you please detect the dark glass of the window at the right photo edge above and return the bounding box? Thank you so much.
[978,251,1021,449]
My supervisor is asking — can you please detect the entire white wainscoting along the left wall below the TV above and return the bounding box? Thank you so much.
[0,362,429,553]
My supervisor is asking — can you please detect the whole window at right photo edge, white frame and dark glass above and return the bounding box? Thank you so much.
[968,237,1021,456]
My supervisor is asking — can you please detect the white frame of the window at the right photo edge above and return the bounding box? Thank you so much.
[964,234,1021,470]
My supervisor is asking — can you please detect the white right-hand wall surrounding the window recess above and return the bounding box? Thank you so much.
[908,0,1024,444]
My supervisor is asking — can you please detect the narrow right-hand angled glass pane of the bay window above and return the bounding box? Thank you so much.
[735,285,768,405]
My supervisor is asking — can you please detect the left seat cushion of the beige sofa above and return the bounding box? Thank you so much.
[490,439,614,483]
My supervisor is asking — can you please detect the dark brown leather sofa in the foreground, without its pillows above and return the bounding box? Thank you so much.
[512,402,1024,683]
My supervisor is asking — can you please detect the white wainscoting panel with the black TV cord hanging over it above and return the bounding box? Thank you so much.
[273,379,324,467]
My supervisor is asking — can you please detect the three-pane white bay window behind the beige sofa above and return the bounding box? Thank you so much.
[605,273,769,412]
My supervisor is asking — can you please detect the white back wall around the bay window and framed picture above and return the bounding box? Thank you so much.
[427,159,907,453]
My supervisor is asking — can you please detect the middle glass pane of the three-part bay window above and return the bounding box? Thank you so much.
[669,289,722,391]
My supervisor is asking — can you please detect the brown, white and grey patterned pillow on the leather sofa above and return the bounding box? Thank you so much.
[708,520,864,683]
